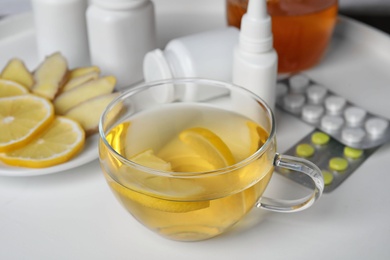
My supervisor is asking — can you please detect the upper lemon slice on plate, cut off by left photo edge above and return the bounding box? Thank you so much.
[0,94,54,152]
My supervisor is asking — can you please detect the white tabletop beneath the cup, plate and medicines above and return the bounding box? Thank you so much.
[0,0,390,260]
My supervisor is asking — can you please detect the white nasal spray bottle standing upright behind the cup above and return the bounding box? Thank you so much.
[232,0,278,109]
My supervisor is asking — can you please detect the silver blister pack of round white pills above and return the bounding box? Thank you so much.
[276,74,390,149]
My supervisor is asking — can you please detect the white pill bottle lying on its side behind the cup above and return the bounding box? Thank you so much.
[143,27,239,82]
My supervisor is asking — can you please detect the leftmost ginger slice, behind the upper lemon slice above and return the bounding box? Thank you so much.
[0,58,34,89]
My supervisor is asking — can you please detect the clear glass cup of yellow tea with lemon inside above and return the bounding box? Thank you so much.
[99,78,324,241]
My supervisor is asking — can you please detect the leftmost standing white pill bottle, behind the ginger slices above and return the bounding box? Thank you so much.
[31,0,90,67]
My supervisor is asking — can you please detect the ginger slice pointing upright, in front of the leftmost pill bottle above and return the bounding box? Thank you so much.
[32,52,68,100]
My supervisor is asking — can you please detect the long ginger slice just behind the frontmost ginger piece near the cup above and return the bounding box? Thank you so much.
[53,76,116,115]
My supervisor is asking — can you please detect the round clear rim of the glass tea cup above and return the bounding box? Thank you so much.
[99,78,276,178]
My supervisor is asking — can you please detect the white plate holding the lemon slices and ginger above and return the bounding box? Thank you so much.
[0,134,99,177]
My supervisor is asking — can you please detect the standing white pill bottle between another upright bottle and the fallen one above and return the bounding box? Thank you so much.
[87,0,156,89]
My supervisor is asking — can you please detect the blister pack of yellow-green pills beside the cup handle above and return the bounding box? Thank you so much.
[276,129,378,192]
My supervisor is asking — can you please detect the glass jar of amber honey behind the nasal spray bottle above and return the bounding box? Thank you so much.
[226,0,338,73]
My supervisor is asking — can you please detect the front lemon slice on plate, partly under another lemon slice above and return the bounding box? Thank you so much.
[0,116,85,168]
